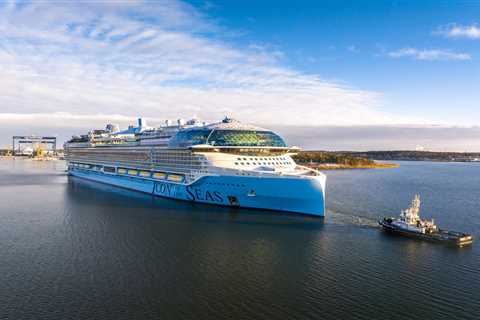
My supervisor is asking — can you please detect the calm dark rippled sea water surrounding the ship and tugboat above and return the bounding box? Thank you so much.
[0,160,480,319]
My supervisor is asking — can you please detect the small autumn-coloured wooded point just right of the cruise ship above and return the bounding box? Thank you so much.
[293,151,375,167]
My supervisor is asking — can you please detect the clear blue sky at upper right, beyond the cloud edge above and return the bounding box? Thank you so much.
[211,1,480,124]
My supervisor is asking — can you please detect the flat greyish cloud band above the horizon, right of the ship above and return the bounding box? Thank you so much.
[273,125,480,152]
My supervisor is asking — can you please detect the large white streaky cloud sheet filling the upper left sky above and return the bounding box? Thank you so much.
[0,0,414,126]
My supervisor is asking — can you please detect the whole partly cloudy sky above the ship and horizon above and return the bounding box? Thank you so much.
[0,0,480,151]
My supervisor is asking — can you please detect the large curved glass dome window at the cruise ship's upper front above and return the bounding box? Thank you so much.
[207,130,286,147]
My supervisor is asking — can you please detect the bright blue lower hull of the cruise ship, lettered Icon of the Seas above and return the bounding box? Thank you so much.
[69,169,325,217]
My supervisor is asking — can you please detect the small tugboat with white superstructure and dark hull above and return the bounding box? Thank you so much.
[378,194,473,247]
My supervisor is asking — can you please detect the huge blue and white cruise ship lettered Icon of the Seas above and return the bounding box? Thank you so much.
[64,117,326,217]
